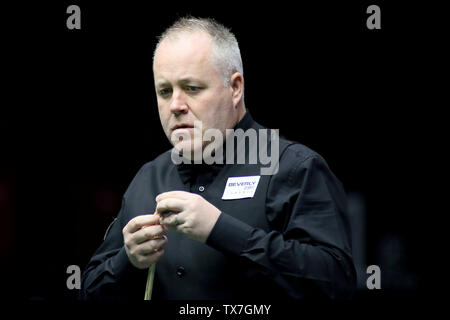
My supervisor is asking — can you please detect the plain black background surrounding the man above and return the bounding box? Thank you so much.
[0,1,446,310]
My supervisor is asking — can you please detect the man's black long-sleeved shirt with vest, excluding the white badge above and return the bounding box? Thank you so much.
[80,112,356,300]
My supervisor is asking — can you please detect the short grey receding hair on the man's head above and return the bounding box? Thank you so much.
[153,16,244,86]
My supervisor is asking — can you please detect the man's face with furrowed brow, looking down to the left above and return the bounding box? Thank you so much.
[153,32,237,158]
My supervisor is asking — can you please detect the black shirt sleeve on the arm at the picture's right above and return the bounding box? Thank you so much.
[207,145,356,299]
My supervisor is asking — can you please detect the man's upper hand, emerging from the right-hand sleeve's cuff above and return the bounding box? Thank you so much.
[156,191,221,243]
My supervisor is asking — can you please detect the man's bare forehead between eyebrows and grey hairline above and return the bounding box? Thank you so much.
[153,31,216,78]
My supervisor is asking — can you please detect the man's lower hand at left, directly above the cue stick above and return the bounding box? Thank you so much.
[122,214,168,269]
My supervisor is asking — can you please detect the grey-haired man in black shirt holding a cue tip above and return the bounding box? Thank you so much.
[81,18,356,300]
